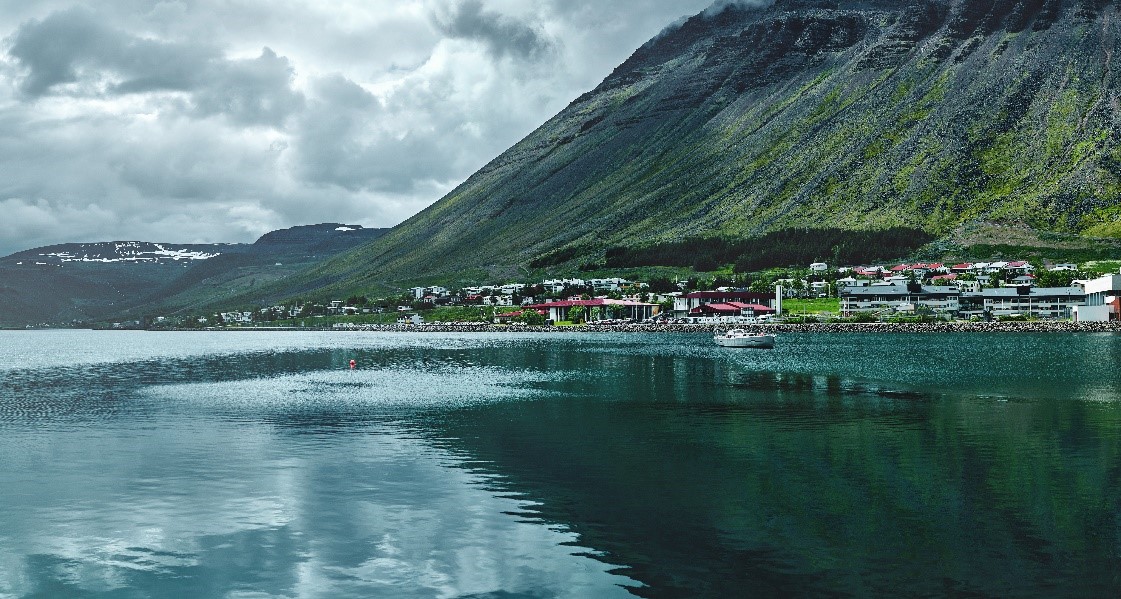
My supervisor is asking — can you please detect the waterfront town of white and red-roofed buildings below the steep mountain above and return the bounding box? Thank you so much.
[146,260,1121,328]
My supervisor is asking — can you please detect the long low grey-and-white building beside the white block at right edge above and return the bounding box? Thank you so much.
[958,286,1086,319]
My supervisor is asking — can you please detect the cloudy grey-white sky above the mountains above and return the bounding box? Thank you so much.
[0,0,728,256]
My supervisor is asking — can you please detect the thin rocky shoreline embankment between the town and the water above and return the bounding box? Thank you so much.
[192,321,1121,333]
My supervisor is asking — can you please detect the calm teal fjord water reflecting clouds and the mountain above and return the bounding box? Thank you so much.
[0,331,1121,598]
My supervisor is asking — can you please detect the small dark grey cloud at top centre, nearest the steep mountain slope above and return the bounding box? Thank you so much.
[434,0,553,58]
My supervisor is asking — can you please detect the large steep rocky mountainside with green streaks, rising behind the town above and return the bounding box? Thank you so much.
[291,0,1121,291]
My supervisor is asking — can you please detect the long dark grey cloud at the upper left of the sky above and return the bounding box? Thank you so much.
[9,8,304,126]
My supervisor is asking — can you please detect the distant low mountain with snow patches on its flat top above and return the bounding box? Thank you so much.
[0,223,386,326]
